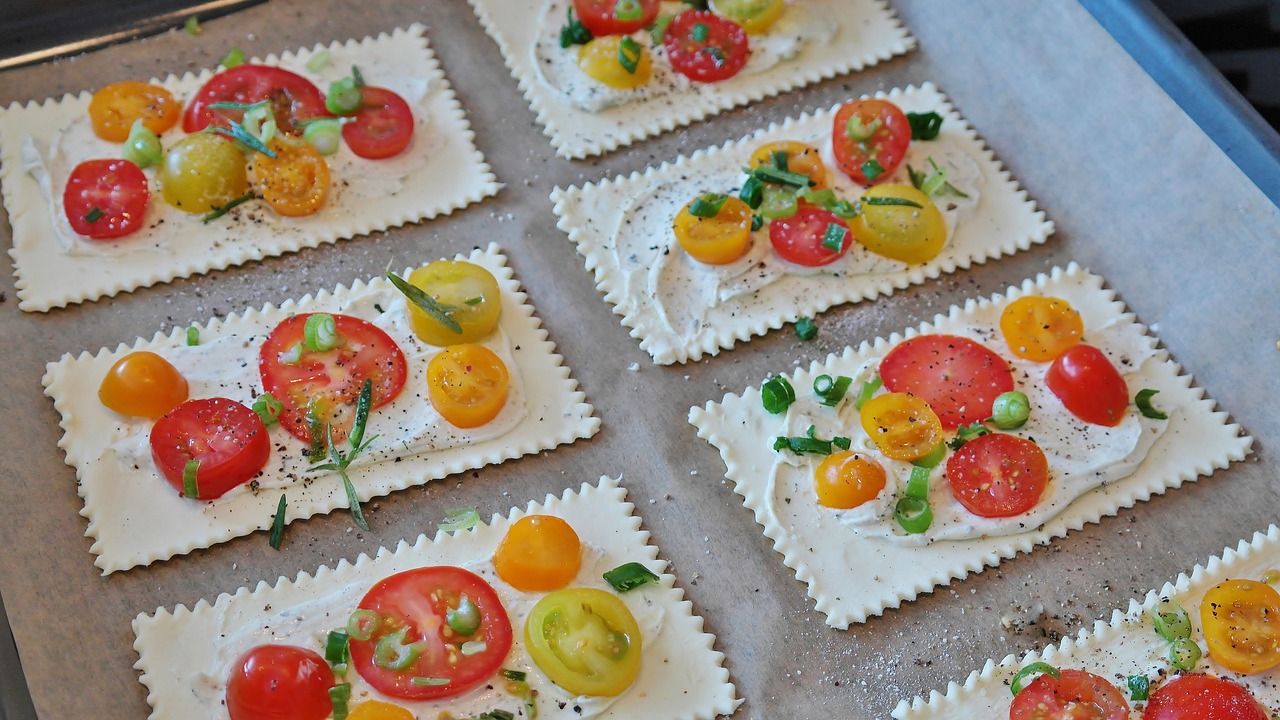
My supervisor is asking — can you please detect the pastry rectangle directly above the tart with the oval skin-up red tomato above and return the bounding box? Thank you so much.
[552,83,1053,364]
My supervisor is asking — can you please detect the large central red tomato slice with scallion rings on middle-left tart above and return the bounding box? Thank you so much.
[257,313,408,443]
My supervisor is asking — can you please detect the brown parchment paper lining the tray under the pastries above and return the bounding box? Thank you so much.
[0,0,1280,719]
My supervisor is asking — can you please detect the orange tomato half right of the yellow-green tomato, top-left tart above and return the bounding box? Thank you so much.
[250,138,329,218]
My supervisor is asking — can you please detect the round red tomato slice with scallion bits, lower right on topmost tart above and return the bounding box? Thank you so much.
[662,10,751,82]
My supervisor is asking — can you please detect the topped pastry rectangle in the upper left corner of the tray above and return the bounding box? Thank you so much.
[0,24,500,311]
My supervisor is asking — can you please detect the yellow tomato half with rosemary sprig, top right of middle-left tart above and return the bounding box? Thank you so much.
[408,260,502,347]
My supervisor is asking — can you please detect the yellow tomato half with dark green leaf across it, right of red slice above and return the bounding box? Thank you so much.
[849,183,947,264]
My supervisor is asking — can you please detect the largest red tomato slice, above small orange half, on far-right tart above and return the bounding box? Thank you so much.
[879,334,1014,429]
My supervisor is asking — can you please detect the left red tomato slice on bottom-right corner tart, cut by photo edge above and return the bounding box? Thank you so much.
[1009,670,1129,720]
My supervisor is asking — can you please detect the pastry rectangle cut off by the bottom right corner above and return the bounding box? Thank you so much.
[892,525,1280,720]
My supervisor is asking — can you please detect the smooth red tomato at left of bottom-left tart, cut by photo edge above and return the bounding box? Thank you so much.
[227,644,334,720]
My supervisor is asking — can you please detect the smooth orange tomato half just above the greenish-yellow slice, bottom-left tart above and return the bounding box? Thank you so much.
[493,515,582,592]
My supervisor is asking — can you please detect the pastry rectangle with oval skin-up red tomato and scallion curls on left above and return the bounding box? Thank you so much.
[689,264,1252,628]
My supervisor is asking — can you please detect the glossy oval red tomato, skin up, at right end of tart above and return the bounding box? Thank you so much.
[1044,343,1129,428]
